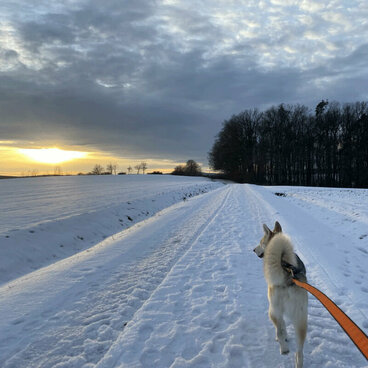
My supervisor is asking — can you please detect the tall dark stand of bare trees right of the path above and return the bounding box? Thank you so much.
[209,100,368,188]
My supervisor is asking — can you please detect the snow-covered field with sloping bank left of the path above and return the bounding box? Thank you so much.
[0,175,222,283]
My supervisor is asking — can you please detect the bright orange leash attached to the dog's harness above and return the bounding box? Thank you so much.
[293,279,368,360]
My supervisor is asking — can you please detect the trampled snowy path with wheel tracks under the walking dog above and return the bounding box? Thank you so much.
[0,185,368,368]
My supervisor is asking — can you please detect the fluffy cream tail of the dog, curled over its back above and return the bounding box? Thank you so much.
[264,233,298,286]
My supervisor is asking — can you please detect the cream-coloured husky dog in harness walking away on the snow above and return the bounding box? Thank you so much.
[254,221,308,368]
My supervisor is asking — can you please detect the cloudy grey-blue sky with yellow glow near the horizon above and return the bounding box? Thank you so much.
[0,0,368,174]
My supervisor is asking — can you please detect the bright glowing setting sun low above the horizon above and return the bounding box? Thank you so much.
[18,148,87,164]
